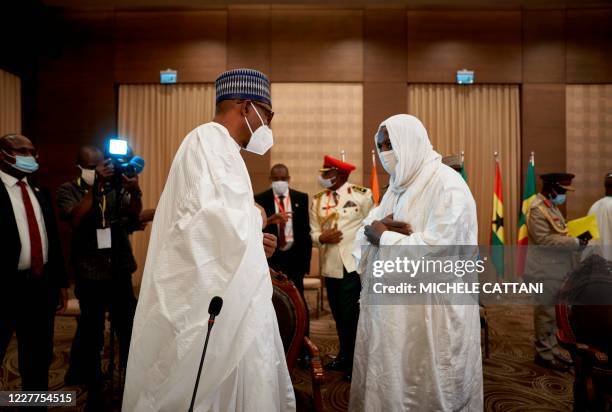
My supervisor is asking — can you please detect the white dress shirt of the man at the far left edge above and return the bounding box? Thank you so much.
[0,170,49,270]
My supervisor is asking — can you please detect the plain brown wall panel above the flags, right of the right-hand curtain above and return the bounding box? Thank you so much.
[521,84,566,185]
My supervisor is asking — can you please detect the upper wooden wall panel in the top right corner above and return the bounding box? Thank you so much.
[566,9,612,83]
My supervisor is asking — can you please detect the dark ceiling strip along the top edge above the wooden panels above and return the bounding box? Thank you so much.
[42,0,612,10]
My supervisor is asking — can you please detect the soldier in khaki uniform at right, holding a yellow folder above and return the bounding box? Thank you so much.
[525,173,587,370]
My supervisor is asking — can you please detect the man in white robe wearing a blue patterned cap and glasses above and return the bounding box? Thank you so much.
[123,69,295,412]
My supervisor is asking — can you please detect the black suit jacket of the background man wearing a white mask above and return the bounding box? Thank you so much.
[255,189,312,275]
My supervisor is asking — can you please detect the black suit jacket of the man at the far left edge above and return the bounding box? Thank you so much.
[0,181,68,289]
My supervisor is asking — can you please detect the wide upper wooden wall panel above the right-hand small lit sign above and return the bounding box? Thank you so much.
[406,11,522,83]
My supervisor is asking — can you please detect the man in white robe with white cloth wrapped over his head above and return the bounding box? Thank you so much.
[349,115,483,412]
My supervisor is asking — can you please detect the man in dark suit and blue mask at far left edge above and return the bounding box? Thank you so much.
[0,134,68,391]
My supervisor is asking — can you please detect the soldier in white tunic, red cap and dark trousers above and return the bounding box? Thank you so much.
[310,156,374,381]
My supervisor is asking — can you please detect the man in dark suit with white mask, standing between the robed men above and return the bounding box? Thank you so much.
[255,164,312,295]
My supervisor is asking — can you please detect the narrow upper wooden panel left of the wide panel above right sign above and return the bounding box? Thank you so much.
[363,9,406,82]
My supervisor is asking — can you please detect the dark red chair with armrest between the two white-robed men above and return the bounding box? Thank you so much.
[271,273,325,411]
